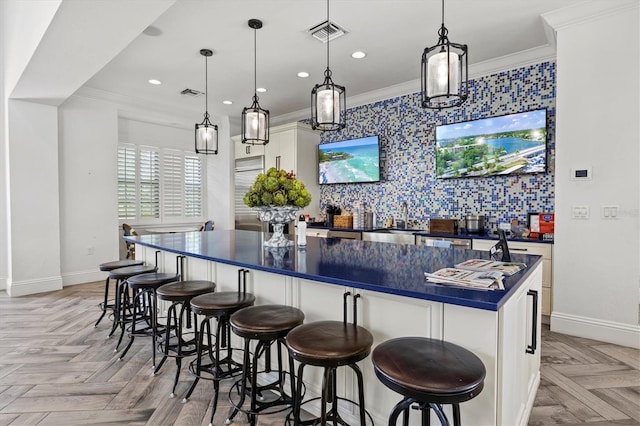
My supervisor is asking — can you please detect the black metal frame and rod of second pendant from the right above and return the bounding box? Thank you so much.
[311,0,347,131]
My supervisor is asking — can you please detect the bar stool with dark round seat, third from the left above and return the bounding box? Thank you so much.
[118,272,180,370]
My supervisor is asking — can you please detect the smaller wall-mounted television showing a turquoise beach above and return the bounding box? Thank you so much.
[318,136,380,185]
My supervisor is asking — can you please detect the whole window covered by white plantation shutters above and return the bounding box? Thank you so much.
[118,144,204,223]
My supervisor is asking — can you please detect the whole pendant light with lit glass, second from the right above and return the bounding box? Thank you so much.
[311,0,347,131]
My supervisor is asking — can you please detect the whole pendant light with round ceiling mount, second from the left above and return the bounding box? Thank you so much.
[242,19,269,145]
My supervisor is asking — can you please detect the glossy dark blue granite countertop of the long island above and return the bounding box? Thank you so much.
[124,230,541,311]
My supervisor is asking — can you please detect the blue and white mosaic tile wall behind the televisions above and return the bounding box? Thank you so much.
[320,62,556,230]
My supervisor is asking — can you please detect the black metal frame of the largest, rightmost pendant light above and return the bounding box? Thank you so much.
[421,0,469,109]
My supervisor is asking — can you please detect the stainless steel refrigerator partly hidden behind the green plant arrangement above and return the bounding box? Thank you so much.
[233,156,264,231]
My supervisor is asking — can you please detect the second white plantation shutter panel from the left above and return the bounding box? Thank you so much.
[139,148,160,219]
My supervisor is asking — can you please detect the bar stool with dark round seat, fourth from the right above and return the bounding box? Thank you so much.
[182,269,256,424]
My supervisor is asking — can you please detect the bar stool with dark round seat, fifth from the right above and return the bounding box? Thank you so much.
[153,281,216,398]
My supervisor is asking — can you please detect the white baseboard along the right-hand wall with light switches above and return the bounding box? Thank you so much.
[551,312,640,349]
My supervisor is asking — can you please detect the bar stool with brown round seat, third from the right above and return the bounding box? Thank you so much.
[226,305,304,425]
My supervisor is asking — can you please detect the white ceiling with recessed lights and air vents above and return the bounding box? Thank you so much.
[77,0,596,134]
